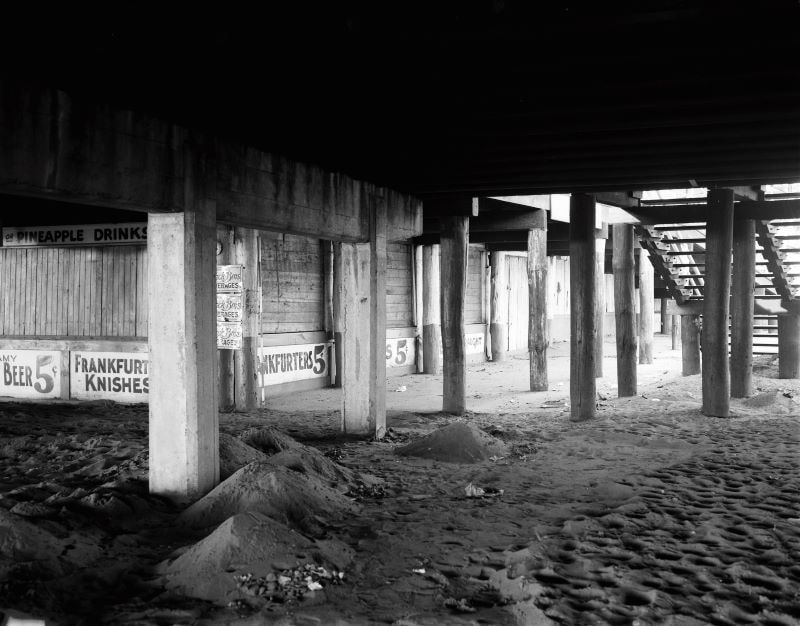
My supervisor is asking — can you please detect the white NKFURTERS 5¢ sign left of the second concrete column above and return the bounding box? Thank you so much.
[258,343,330,387]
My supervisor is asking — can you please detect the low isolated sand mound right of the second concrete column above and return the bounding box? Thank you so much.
[397,422,509,463]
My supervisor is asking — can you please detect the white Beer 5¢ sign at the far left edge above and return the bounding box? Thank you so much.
[0,350,61,398]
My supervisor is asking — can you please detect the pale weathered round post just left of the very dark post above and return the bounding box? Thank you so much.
[528,227,547,391]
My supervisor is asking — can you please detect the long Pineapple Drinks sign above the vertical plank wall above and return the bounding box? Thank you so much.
[3,222,147,248]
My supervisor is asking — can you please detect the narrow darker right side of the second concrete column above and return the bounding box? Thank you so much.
[369,195,388,439]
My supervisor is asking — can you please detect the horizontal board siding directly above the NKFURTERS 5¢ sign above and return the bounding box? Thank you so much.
[261,233,325,333]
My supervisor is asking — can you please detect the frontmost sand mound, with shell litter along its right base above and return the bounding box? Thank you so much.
[162,512,352,604]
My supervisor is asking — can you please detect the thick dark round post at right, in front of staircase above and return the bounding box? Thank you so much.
[701,189,733,417]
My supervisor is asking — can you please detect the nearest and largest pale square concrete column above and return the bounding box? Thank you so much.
[147,199,219,501]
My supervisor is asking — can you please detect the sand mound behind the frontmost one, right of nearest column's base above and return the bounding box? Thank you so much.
[178,461,357,532]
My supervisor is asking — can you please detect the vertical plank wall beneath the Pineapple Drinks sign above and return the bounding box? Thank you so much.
[0,246,147,337]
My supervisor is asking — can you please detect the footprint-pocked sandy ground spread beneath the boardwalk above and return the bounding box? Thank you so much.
[0,338,800,625]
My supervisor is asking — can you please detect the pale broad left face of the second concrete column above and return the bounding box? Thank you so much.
[336,243,370,435]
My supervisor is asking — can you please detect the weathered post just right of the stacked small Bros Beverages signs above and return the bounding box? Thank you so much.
[233,227,261,411]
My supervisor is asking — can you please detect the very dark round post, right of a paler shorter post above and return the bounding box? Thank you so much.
[569,194,597,421]
